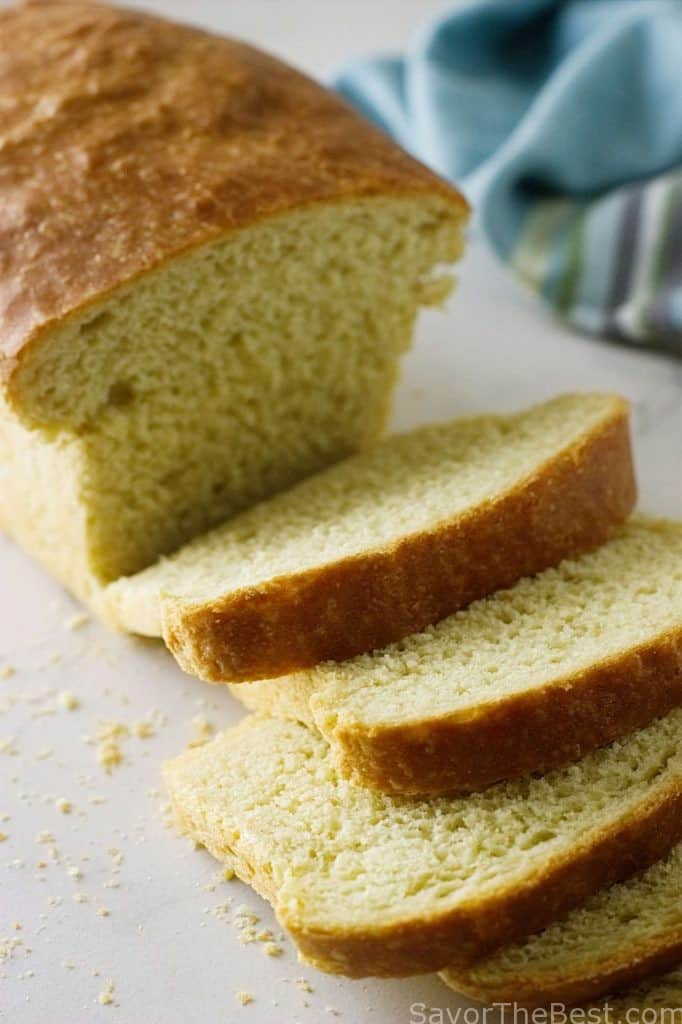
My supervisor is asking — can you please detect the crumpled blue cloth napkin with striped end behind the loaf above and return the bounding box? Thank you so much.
[335,0,682,354]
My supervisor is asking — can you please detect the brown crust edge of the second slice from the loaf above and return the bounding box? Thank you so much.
[328,624,682,795]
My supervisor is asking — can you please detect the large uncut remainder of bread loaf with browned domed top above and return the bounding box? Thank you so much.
[0,0,467,604]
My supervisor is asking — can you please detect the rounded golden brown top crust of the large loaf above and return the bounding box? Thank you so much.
[0,0,466,380]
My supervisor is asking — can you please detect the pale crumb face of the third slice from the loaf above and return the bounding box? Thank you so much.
[165,712,682,974]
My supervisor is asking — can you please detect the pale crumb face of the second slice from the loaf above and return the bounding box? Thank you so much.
[237,519,682,741]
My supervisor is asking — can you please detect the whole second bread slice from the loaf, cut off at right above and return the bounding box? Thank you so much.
[233,519,682,794]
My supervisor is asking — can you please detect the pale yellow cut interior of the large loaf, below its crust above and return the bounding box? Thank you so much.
[0,197,461,596]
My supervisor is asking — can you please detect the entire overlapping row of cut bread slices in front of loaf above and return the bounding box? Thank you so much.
[160,387,682,1019]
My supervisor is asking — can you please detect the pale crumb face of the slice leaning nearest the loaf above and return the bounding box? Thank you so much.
[103,394,624,636]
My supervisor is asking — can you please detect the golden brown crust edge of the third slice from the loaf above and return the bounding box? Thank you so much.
[278,780,682,978]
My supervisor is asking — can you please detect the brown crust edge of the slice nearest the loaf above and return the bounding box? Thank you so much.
[163,402,636,682]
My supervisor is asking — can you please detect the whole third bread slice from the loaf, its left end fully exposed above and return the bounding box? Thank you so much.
[165,711,682,977]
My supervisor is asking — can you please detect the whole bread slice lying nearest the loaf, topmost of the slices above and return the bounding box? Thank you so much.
[102,394,635,682]
